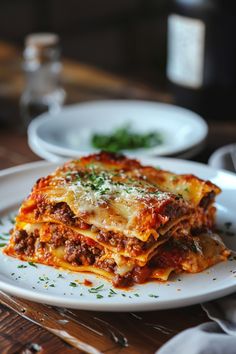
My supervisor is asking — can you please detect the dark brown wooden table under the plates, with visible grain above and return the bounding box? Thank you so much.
[0,43,236,354]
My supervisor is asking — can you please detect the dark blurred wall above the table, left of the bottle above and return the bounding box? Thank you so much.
[0,0,168,84]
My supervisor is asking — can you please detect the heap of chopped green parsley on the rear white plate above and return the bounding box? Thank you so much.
[91,124,163,152]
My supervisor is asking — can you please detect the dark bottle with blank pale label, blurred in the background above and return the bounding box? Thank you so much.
[167,0,236,119]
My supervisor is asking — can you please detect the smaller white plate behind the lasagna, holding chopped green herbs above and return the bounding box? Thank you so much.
[28,100,208,157]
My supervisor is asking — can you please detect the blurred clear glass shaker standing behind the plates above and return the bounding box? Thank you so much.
[20,33,66,128]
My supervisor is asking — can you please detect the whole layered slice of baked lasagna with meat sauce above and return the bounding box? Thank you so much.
[5,152,229,287]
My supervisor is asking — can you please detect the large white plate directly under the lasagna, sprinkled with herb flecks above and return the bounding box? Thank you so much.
[0,158,236,311]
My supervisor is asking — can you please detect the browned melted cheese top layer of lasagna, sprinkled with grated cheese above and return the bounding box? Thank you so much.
[20,155,203,241]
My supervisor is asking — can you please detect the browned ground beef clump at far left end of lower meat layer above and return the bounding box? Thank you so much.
[14,230,36,256]
